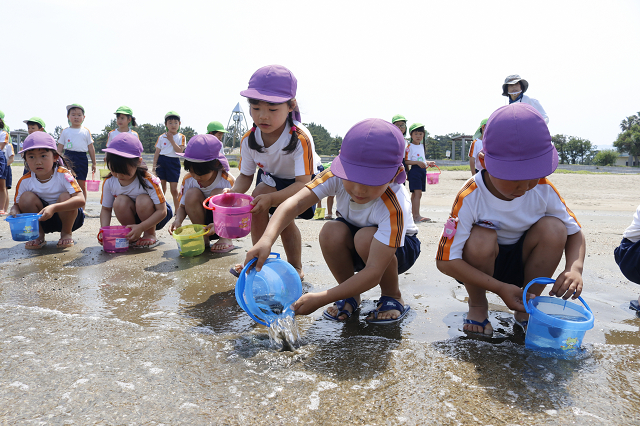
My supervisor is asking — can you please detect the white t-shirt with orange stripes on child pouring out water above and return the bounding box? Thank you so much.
[307,170,418,247]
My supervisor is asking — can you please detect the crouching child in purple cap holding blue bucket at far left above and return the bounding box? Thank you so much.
[9,132,85,250]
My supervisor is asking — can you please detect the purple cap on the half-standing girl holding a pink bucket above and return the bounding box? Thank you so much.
[240,65,302,121]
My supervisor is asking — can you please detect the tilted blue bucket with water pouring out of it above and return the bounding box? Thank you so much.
[236,253,302,326]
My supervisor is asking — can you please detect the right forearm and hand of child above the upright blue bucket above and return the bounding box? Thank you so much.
[549,231,587,300]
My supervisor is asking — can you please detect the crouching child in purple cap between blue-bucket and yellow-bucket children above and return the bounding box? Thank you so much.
[100,133,173,248]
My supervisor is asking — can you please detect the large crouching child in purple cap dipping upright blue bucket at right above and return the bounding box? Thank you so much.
[436,103,585,335]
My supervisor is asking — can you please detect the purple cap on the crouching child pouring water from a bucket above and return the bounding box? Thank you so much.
[331,118,407,186]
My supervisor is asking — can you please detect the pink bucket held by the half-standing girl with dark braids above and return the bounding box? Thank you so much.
[202,192,253,238]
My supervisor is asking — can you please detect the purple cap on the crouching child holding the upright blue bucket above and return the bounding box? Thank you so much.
[482,103,558,180]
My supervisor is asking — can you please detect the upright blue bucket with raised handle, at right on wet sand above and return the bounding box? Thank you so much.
[522,278,593,356]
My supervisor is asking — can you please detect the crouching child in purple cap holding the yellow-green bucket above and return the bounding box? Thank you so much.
[169,134,235,253]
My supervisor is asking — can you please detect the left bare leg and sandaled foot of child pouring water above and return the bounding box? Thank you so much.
[318,220,360,320]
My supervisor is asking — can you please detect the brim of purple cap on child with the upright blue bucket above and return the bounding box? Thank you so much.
[484,145,558,180]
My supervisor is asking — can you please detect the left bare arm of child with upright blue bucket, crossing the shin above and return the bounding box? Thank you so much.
[436,259,530,312]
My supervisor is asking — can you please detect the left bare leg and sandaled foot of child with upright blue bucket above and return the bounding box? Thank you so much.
[462,226,500,334]
